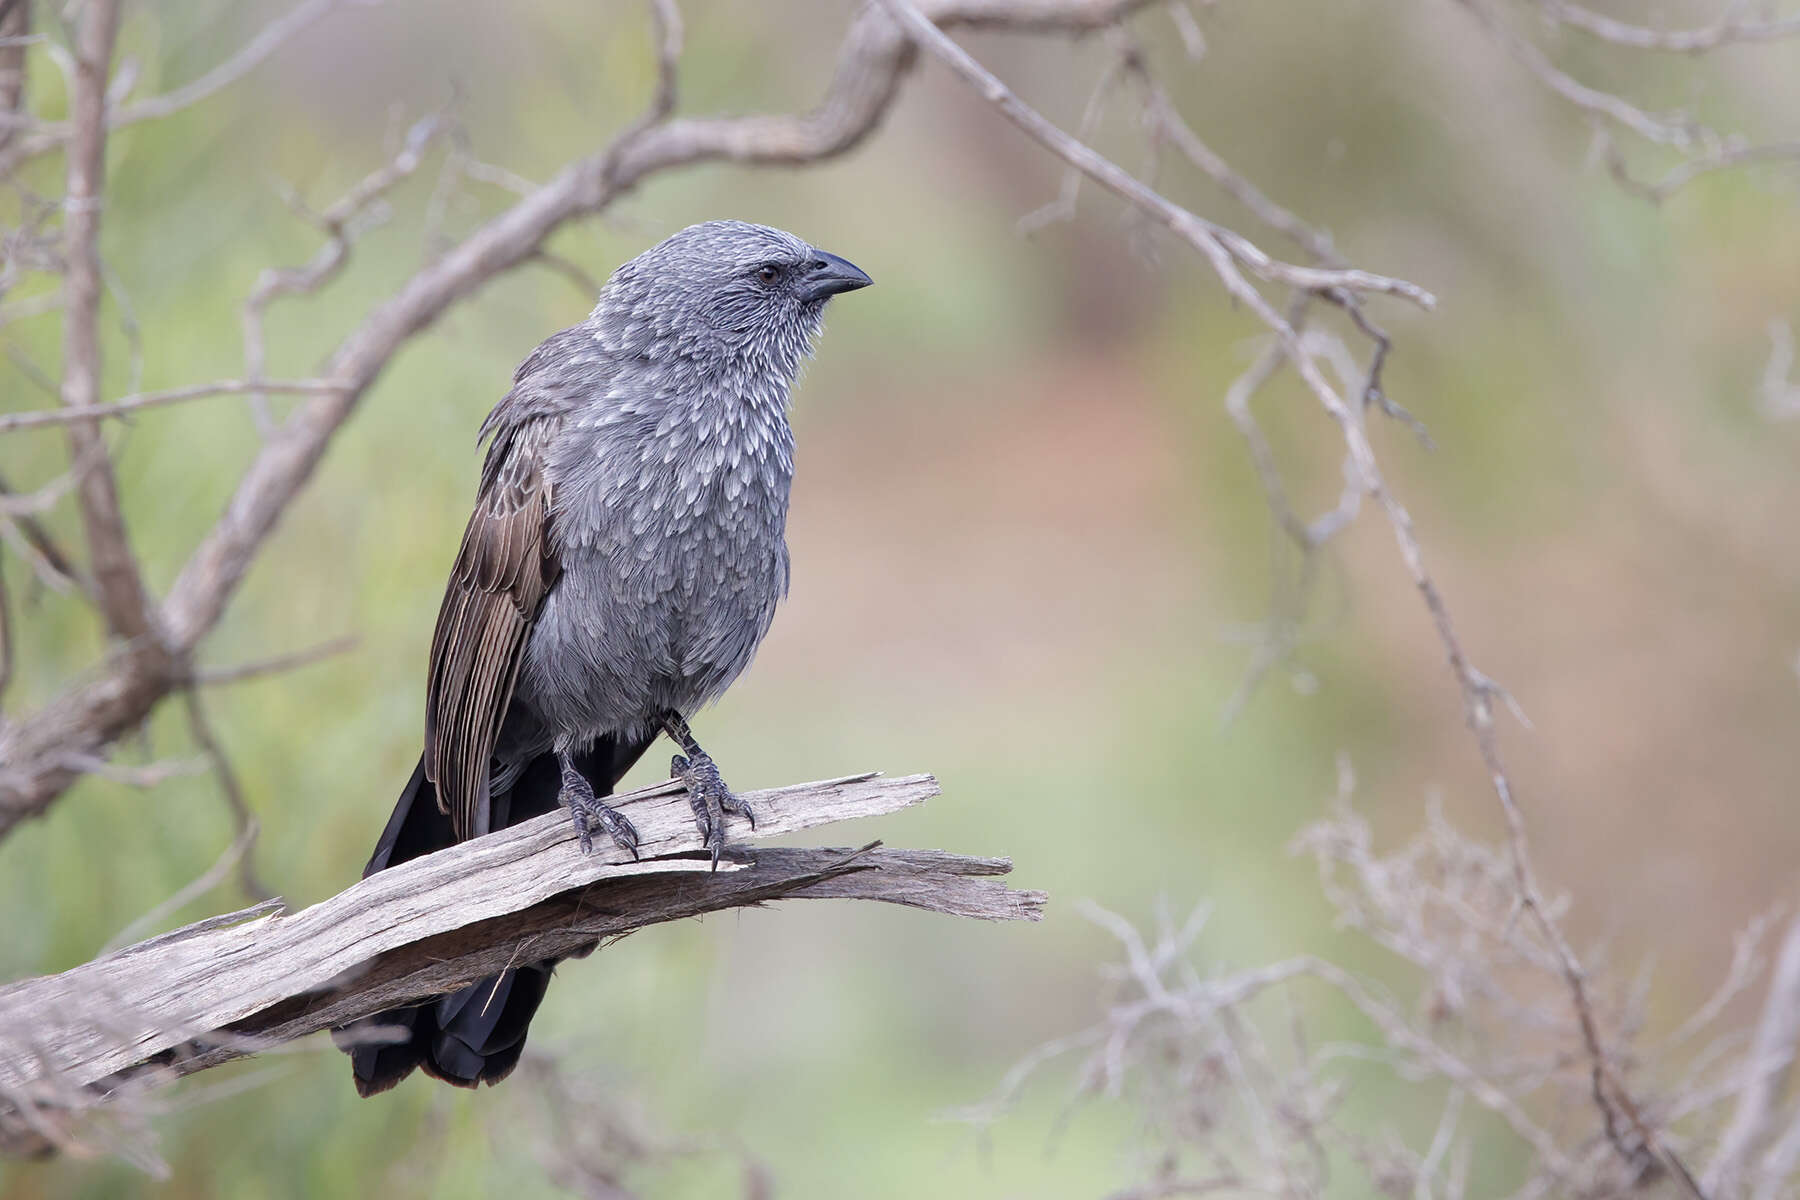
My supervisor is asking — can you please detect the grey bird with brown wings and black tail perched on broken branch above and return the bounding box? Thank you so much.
[340,221,869,1096]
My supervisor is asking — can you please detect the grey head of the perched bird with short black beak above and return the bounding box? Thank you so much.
[592,221,869,376]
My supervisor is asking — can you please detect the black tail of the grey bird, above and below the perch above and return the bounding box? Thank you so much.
[337,738,650,1096]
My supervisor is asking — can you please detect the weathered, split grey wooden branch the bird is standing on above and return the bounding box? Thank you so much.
[0,775,1044,1150]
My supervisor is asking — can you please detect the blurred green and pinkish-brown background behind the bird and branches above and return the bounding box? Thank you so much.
[0,0,1800,1200]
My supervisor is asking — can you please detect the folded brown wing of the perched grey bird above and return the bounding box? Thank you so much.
[425,421,560,840]
